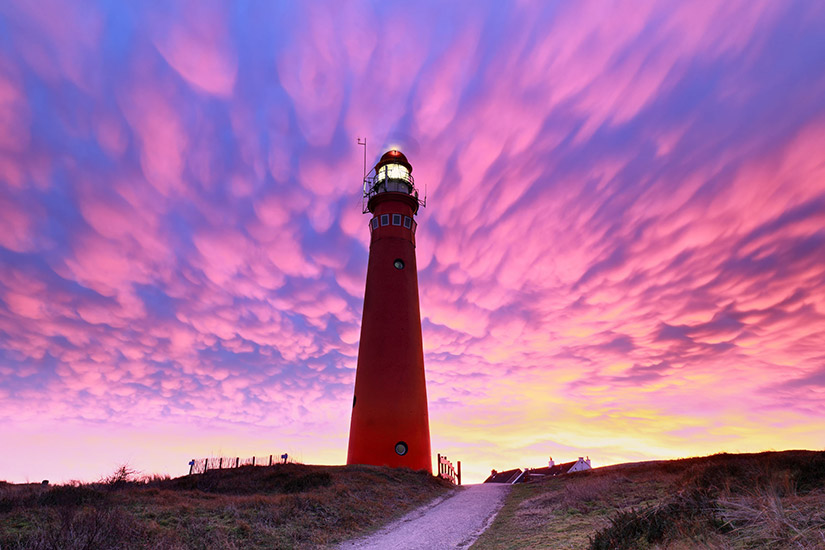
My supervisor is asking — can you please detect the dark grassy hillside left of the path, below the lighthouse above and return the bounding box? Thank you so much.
[0,464,451,550]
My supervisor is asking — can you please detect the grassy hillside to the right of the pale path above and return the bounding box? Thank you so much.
[472,451,825,550]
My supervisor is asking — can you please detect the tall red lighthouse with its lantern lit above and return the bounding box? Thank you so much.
[347,149,432,473]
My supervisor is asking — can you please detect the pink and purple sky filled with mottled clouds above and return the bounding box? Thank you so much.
[0,0,825,482]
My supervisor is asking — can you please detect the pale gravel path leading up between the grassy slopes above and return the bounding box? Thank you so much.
[339,483,510,550]
